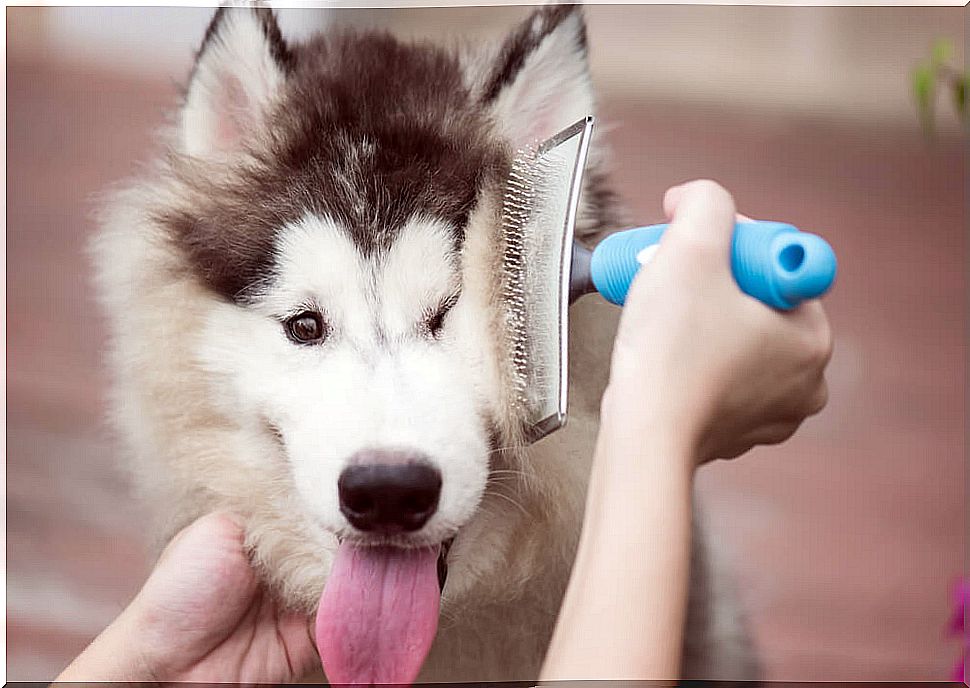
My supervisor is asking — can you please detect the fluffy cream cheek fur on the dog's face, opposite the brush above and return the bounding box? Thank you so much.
[91,184,328,609]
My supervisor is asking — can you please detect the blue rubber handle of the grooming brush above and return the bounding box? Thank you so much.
[589,221,836,310]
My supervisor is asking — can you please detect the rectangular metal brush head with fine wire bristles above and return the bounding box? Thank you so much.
[500,117,593,442]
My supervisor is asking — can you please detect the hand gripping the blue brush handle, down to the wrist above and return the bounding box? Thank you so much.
[603,181,832,463]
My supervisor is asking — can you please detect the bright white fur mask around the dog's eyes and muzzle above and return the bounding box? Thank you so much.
[197,217,494,544]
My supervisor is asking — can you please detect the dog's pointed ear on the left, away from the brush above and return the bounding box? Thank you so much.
[179,7,292,157]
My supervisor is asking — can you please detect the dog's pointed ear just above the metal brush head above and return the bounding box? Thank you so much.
[481,5,594,148]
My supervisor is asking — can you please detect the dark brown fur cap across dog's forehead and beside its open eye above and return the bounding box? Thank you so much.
[158,29,509,302]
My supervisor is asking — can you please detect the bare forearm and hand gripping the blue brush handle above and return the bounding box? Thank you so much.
[541,182,832,680]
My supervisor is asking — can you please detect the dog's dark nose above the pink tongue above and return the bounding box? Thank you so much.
[337,452,441,534]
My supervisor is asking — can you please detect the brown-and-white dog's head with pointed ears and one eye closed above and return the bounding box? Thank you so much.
[108,6,609,616]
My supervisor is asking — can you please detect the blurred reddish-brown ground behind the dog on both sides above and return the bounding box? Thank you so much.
[7,21,966,680]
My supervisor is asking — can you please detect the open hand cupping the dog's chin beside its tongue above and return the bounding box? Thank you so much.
[57,513,320,683]
